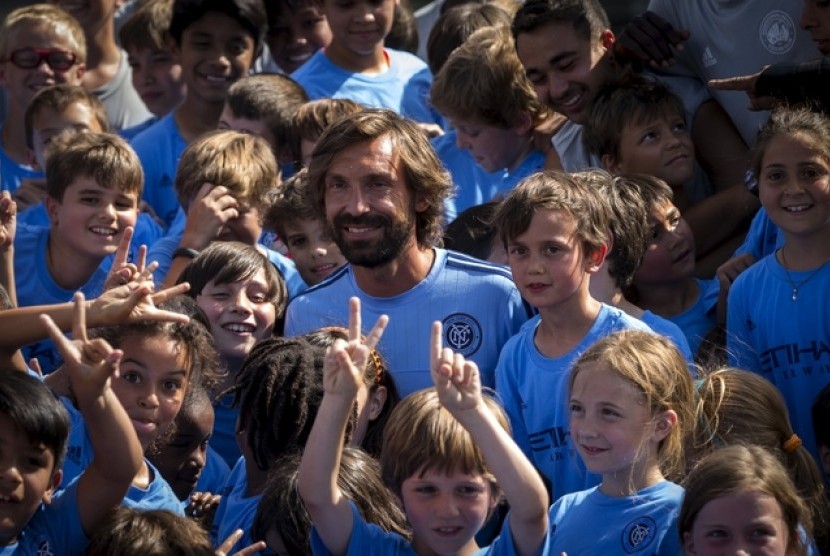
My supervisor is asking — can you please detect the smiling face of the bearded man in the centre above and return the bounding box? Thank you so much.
[324,137,417,268]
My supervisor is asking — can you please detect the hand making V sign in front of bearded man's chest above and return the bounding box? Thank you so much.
[323,297,389,397]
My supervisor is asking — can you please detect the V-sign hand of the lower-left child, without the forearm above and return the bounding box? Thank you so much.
[40,292,123,407]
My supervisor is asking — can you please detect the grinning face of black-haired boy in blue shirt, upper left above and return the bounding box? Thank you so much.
[172,12,254,104]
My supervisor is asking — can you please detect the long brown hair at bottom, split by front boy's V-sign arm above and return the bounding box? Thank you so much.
[251,446,410,556]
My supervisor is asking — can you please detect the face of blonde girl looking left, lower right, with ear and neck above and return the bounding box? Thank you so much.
[569,365,671,495]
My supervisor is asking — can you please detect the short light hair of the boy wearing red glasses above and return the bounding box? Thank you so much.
[0,2,86,63]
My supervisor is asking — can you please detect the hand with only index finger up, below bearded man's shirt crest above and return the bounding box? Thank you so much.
[430,321,481,414]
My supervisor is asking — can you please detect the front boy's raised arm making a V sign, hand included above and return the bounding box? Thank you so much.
[297,297,388,555]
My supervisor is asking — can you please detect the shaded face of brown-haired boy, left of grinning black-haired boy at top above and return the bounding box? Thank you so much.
[127,48,187,117]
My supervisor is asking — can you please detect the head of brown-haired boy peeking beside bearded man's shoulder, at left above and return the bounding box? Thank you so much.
[264,169,346,287]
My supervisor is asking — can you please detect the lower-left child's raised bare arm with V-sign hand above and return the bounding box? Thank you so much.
[42,293,144,535]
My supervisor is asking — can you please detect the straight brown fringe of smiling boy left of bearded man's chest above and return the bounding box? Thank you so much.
[178,241,288,320]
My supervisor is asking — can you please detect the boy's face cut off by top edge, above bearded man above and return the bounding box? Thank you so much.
[323,0,396,56]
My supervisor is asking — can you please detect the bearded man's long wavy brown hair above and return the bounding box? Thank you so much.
[308,109,452,248]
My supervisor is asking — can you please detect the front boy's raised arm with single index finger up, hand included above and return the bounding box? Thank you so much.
[430,322,549,555]
